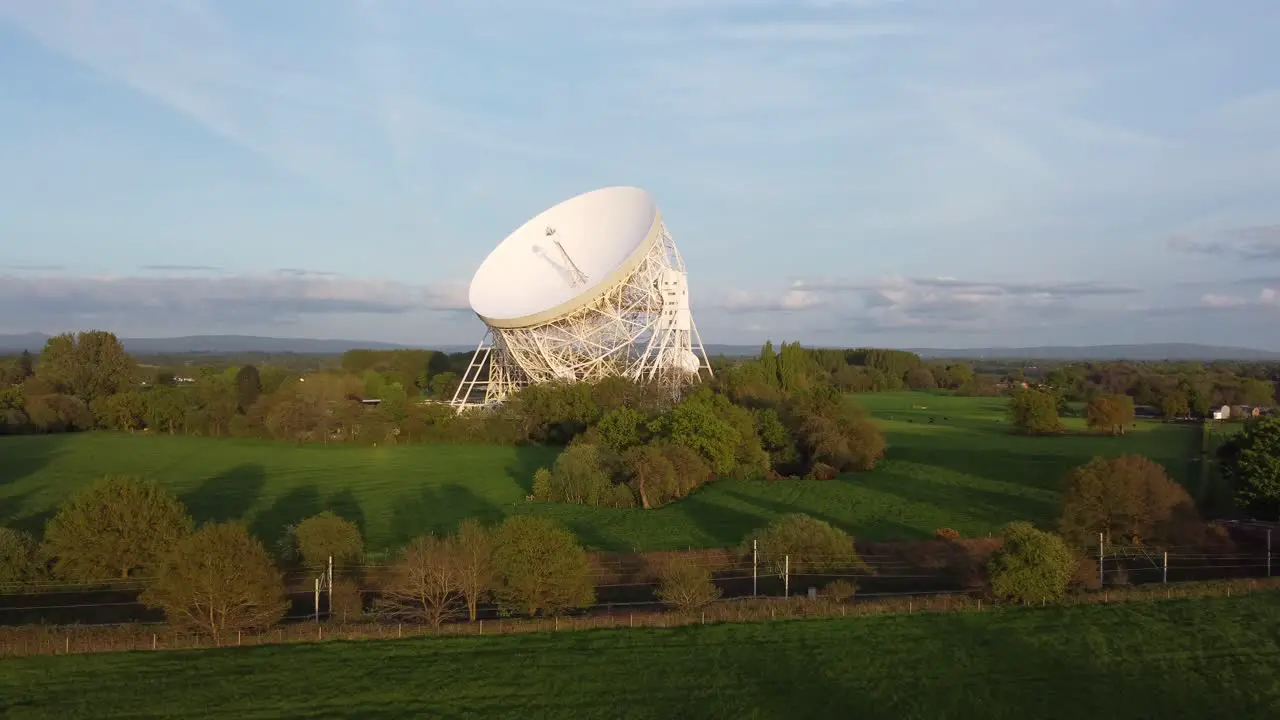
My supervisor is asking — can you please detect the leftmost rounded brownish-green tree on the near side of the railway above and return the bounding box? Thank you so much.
[141,523,288,642]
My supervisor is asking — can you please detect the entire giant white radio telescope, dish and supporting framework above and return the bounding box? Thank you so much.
[452,187,710,413]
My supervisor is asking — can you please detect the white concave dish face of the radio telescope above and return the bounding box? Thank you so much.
[468,187,662,328]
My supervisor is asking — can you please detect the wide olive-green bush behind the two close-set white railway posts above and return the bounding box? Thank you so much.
[744,514,864,575]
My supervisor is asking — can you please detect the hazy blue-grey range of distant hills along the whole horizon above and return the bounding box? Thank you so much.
[0,333,1280,361]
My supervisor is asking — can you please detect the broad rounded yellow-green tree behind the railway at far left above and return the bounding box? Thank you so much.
[42,477,192,582]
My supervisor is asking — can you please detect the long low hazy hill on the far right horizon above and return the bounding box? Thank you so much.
[910,342,1280,361]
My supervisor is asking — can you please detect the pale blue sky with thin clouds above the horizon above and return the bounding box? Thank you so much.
[0,0,1280,348]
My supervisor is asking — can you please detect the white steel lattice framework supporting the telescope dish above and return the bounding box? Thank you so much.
[452,220,712,411]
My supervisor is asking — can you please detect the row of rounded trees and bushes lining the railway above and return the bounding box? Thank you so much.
[0,445,1233,639]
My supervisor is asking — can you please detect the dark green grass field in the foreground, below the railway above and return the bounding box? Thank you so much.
[0,593,1280,720]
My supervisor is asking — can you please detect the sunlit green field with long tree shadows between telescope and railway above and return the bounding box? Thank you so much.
[0,392,1201,551]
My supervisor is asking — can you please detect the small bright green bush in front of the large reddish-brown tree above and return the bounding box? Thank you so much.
[987,523,1078,602]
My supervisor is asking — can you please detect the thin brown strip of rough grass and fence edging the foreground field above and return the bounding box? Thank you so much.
[0,578,1280,657]
